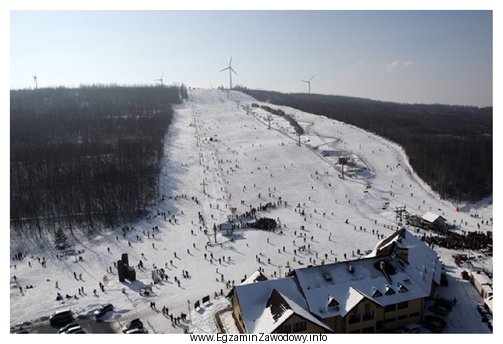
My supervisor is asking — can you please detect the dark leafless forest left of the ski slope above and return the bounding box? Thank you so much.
[10,85,187,231]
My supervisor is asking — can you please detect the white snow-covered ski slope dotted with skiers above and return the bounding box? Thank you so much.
[10,90,492,333]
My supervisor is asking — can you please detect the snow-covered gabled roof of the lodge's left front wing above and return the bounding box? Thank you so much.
[235,277,331,333]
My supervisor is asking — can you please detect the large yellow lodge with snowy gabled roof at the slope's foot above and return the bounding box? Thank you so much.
[231,229,441,333]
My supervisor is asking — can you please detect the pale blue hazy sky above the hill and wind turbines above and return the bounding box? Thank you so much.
[10,10,493,106]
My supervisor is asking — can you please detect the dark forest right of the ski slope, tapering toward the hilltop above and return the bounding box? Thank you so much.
[241,89,493,201]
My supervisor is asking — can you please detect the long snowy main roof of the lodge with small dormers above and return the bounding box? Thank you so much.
[295,230,441,318]
